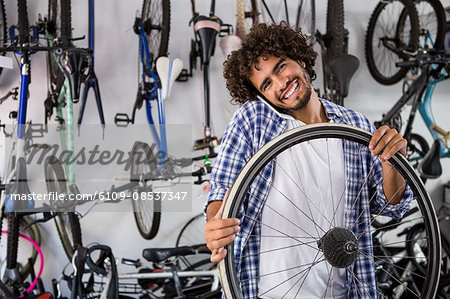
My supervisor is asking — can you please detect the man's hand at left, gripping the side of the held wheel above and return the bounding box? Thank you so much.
[205,190,240,263]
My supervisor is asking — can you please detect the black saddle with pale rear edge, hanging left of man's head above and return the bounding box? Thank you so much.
[194,16,222,64]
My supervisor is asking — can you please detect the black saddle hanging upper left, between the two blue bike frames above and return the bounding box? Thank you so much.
[61,48,91,103]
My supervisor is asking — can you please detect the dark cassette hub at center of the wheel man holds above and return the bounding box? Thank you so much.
[317,227,358,268]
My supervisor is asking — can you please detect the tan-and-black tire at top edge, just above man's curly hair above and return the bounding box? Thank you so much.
[236,0,260,38]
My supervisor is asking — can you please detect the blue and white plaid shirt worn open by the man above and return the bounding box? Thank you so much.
[205,99,412,299]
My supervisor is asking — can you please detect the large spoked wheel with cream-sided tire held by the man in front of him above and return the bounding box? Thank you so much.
[219,124,440,298]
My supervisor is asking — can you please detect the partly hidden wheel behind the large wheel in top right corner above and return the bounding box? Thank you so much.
[399,0,446,50]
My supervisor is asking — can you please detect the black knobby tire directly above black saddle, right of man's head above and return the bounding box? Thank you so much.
[326,0,347,60]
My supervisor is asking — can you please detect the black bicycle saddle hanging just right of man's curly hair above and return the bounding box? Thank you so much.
[328,54,359,98]
